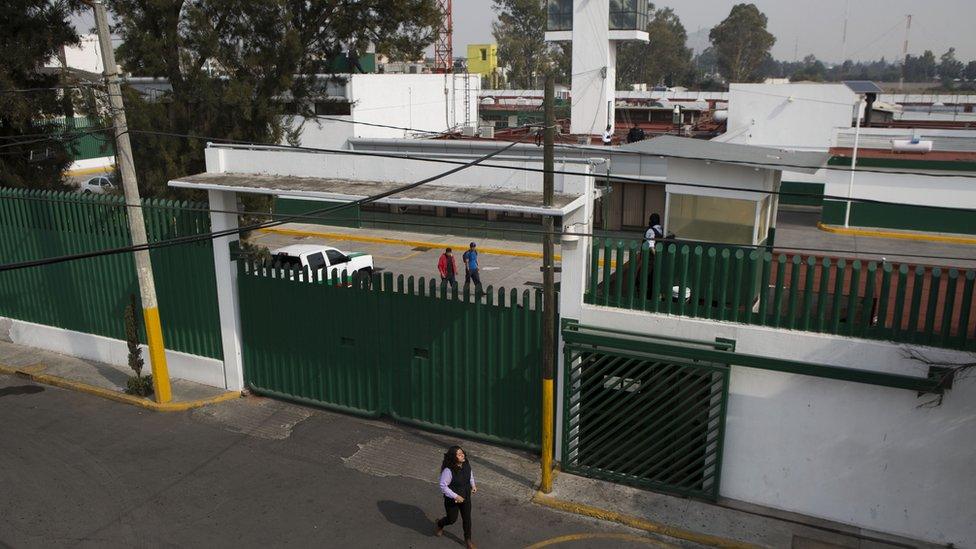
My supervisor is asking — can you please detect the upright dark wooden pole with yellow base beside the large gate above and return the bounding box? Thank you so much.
[539,70,556,494]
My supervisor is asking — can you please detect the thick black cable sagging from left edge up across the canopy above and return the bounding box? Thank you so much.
[0,133,518,272]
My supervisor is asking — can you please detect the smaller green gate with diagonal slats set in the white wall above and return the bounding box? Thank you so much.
[562,331,729,499]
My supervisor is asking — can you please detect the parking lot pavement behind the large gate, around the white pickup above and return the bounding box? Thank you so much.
[248,228,559,291]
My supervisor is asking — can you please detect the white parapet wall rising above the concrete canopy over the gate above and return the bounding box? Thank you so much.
[207,147,587,194]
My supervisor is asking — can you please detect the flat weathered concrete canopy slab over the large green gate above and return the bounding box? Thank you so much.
[169,173,585,216]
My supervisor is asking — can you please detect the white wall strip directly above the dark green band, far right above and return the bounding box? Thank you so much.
[824,168,976,212]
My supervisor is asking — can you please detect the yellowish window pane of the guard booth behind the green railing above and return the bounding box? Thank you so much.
[667,194,756,245]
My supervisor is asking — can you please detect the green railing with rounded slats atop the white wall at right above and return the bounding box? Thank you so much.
[586,239,976,349]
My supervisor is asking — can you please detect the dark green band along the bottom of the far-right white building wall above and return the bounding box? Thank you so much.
[820,200,976,234]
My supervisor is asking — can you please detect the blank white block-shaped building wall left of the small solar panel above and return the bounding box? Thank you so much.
[726,84,857,150]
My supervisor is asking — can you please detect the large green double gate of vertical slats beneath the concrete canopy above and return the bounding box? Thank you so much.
[238,261,542,448]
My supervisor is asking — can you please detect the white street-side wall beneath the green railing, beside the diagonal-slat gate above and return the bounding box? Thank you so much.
[563,302,976,547]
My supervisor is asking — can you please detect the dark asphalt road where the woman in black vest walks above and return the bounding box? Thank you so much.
[0,375,692,548]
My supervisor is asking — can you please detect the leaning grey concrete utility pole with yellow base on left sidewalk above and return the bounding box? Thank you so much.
[85,0,173,403]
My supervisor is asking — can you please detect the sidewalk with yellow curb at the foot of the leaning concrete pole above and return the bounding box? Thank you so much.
[0,341,241,412]
